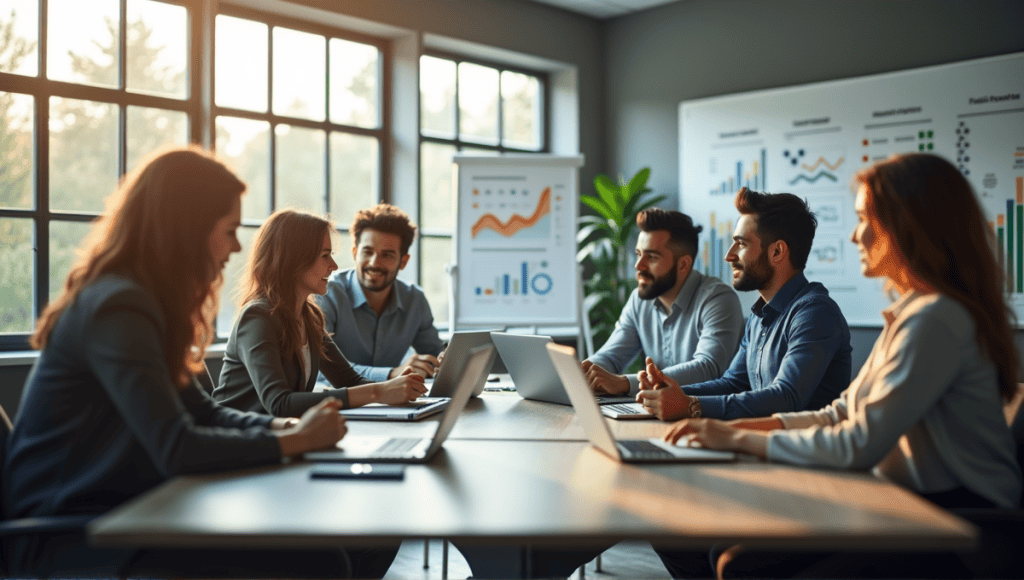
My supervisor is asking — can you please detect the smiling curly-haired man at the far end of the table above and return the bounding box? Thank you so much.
[316,204,444,382]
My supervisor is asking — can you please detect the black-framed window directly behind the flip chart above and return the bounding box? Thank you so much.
[419,54,548,324]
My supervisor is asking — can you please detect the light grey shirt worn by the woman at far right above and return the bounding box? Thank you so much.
[767,292,1021,507]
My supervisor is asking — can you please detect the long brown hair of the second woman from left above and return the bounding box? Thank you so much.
[238,209,334,364]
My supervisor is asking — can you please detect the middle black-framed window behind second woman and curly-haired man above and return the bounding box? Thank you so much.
[213,10,388,335]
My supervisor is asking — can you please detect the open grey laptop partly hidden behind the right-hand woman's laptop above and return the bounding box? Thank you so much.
[490,332,636,405]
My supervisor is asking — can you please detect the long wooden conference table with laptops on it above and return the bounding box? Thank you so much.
[89,392,977,573]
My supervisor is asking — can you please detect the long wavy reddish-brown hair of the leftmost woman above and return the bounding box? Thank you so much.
[31,146,246,388]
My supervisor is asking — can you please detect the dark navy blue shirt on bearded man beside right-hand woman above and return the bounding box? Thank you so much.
[683,273,853,419]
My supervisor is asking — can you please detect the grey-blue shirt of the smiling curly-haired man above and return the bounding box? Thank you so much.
[316,268,444,382]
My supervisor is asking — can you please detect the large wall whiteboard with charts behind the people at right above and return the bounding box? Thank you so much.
[679,53,1024,326]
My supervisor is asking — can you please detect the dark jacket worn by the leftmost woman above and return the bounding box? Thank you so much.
[2,275,281,517]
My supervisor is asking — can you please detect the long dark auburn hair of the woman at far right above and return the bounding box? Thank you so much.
[856,154,1019,401]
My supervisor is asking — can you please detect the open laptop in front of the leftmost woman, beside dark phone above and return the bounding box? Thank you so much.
[303,344,495,463]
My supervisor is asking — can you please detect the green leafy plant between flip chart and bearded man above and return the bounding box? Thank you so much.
[577,167,665,348]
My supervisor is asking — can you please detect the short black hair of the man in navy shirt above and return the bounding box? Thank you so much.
[736,188,818,270]
